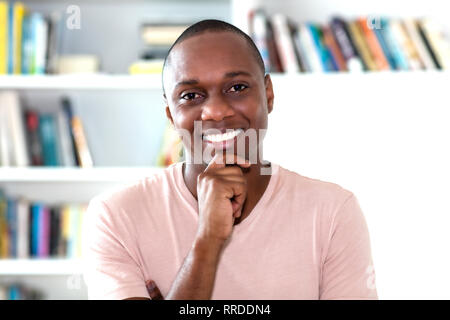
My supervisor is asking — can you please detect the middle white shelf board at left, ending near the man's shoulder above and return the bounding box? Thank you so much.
[0,167,164,183]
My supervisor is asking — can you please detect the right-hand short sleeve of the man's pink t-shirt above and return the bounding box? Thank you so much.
[320,194,378,300]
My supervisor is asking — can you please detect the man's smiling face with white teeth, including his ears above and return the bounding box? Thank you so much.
[163,32,274,162]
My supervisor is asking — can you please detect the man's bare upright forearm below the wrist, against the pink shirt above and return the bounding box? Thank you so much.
[165,238,222,300]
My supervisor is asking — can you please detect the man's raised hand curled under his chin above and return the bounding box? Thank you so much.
[197,153,250,244]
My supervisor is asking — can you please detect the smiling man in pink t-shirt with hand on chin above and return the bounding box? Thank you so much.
[83,20,377,299]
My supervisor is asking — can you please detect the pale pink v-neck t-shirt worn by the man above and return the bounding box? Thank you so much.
[83,162,378,299]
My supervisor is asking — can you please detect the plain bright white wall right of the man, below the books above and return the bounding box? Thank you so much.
[264,73,450,299]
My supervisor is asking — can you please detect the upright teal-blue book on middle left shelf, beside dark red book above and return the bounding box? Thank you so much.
[39,113,60,166]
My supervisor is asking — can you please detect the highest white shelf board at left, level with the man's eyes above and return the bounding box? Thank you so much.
[0,74,161,90]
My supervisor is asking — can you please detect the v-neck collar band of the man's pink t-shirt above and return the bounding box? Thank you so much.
[173,161,280,232]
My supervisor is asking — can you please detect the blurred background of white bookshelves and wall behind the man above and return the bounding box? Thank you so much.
[0,0,450,299]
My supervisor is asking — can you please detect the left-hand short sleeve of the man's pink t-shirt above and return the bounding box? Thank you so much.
[82,198,149,299]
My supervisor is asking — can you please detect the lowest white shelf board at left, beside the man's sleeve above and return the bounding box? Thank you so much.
[0,258,83,276]
